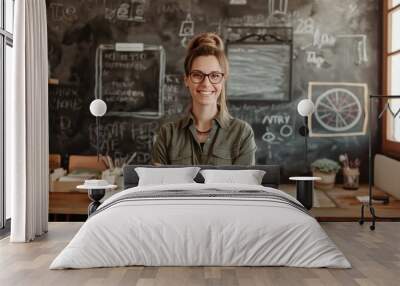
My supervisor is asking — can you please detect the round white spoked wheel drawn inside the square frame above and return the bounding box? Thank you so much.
[315,88,362,132]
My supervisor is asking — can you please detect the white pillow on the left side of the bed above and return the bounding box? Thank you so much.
[135,167,200,186]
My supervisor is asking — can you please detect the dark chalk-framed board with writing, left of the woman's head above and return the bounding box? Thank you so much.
[95,43,165,118]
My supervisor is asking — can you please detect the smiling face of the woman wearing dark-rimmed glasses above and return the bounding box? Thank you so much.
[185,56,224,105]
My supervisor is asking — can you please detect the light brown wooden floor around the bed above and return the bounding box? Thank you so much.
[0,222,400,286]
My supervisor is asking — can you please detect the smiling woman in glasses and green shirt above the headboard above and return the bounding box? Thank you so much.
[152,33,256,165]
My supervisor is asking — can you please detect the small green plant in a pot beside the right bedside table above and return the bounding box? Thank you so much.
[311,158,340,190]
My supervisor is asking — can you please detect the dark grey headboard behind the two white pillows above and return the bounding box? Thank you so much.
[124,165,280,189]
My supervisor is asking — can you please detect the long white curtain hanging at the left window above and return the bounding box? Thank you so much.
[6,0,49,242]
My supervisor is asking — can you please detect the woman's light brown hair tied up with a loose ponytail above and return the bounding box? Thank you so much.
[184,33,232,122]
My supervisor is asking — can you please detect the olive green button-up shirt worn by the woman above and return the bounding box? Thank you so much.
[152,112,257,165]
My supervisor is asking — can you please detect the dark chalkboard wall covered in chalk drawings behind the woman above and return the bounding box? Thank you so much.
[47,0,380,181]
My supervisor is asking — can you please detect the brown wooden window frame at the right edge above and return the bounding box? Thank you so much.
[382,0,400,159]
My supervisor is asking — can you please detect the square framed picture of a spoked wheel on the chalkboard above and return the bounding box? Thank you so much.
[308,82,368,137]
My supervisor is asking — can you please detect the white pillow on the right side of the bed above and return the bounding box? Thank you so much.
[200,169,265,185]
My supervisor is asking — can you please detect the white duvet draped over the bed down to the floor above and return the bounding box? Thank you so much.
[50,183,351,269]
